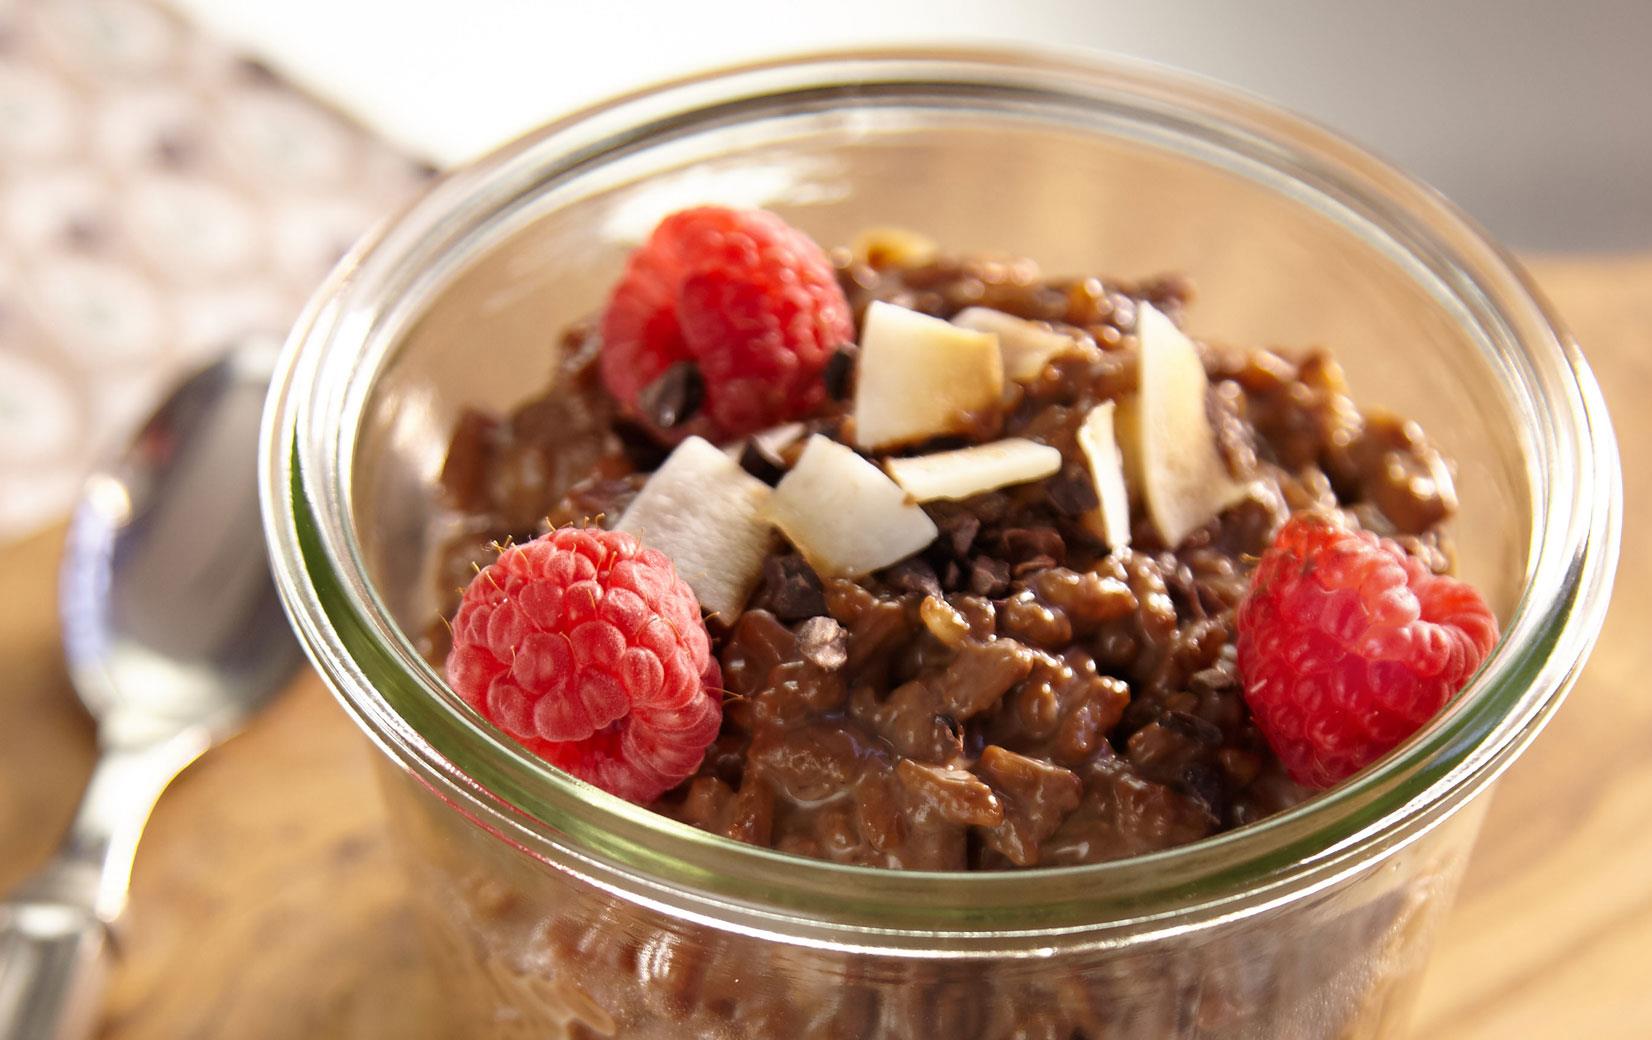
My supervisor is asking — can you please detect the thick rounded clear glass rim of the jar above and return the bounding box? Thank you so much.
[259,48,1622,951]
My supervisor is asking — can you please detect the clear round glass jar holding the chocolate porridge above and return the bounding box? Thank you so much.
[261,51,1621,1040]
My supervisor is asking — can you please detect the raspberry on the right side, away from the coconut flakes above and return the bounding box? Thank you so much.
[1237,513,1497,787]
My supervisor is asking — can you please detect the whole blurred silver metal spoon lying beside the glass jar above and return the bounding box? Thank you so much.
[0,342,301,1040]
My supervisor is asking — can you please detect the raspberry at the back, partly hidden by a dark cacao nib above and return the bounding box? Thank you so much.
[601,206,854,437]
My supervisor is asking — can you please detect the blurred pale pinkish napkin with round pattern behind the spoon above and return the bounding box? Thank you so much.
[0,0,430,541]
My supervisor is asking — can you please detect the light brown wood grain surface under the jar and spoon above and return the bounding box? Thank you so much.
[0,256,1652,1040]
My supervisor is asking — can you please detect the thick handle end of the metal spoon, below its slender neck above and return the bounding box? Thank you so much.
[0,898,109,1040]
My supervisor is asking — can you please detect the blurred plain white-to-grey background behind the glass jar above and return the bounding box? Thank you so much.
[172,0,1652,251]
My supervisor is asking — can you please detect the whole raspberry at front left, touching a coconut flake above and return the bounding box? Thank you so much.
[448,528,722,802]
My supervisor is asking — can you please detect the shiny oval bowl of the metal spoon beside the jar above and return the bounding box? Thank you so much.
[59,342,301,746]
